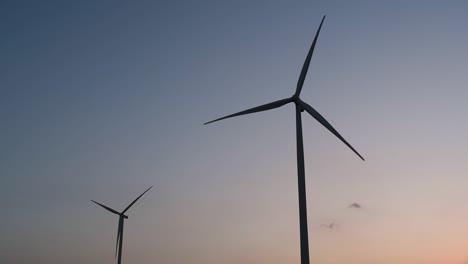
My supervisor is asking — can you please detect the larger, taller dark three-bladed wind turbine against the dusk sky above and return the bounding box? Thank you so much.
[204,16,364,264]
